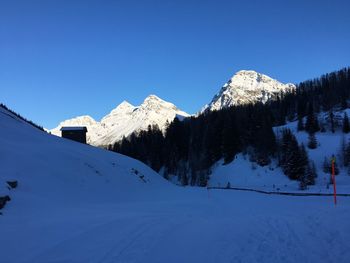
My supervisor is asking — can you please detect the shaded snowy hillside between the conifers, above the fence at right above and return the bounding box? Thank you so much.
[209,110,350,193]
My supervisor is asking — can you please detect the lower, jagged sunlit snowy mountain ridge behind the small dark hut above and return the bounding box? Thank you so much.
[51,95,189,146]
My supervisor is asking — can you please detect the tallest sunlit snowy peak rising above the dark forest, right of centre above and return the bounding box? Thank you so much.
[202,70,296,112]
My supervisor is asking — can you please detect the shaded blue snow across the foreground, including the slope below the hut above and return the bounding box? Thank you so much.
[0,105,350,263]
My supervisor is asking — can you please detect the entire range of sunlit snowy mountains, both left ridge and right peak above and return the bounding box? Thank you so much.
[50,70,296,146]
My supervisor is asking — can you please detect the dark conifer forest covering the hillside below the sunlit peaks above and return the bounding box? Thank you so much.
[109,68,350,189]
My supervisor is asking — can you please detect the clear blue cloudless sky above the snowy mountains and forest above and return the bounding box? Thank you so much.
[0,0,350,128]
